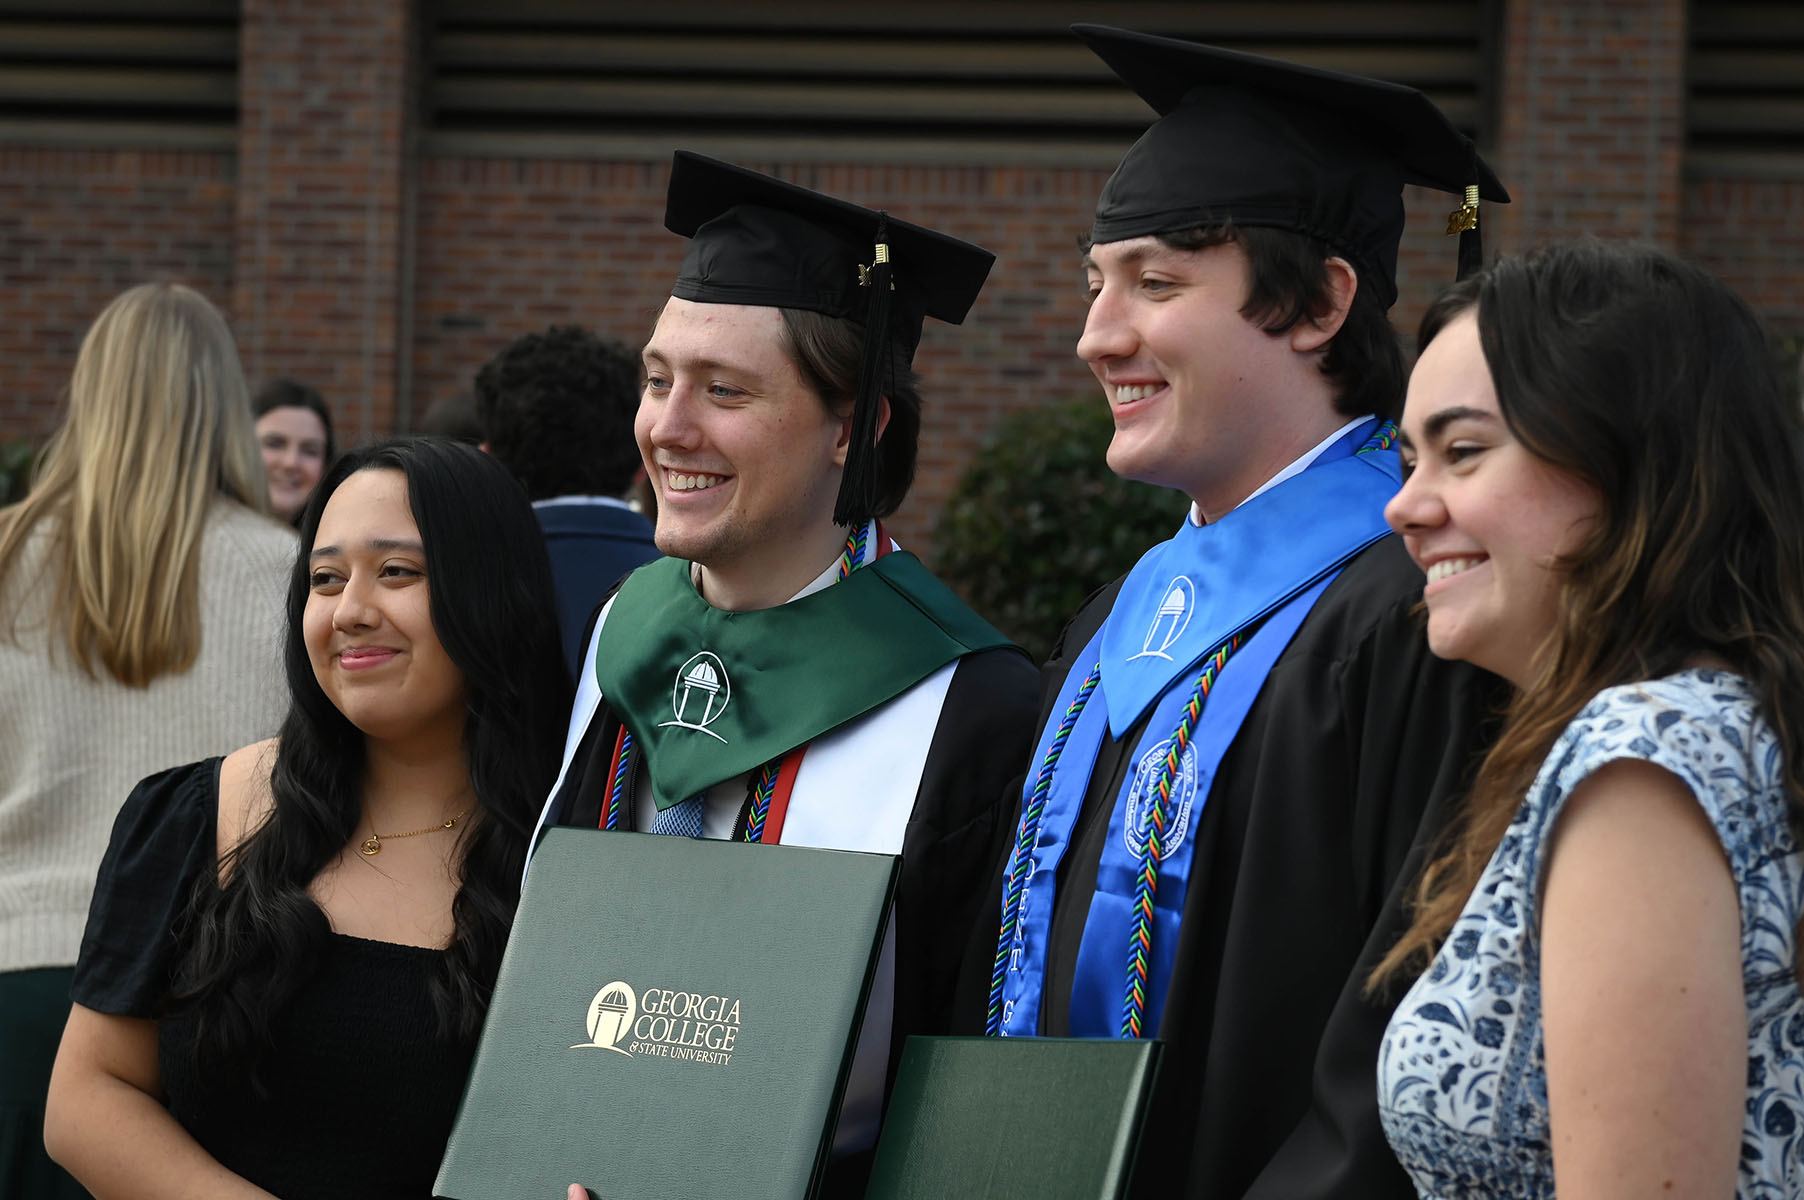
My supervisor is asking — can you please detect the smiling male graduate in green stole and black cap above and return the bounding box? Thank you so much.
[526,152,1039,1195]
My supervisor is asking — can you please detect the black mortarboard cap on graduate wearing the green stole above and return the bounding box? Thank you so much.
[664,150,996,525]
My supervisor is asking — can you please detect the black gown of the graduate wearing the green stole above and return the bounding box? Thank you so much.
[548,646,1039,1198]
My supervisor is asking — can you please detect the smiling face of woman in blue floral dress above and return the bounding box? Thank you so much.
[1384,310,1600,688]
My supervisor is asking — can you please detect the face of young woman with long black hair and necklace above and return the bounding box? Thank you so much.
[301,469,464,740]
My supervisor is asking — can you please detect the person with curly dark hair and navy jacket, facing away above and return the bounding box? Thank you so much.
[476,325,658,671]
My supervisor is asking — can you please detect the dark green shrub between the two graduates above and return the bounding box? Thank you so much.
[933,395,1189,660]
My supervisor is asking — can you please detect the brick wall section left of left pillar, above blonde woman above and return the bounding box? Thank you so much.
[0,146,235,437]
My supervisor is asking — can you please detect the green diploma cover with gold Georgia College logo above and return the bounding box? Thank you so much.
[435,828,897,1200]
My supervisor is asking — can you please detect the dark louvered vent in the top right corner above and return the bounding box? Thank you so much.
[1685,0,1804,179]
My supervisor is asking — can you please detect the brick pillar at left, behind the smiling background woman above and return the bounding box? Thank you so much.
[233,0,413,440]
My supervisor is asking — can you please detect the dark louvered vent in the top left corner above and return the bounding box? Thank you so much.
[0,0,238,150]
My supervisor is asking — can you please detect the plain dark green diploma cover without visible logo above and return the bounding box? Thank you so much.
[866,1038,1162,1200]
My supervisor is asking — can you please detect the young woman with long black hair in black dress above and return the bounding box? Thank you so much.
[45,438,570,1200]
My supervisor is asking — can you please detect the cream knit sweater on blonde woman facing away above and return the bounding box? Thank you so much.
[0,500,296,971]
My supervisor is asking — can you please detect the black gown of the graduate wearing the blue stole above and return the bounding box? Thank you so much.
[960,536,1503,1200]
